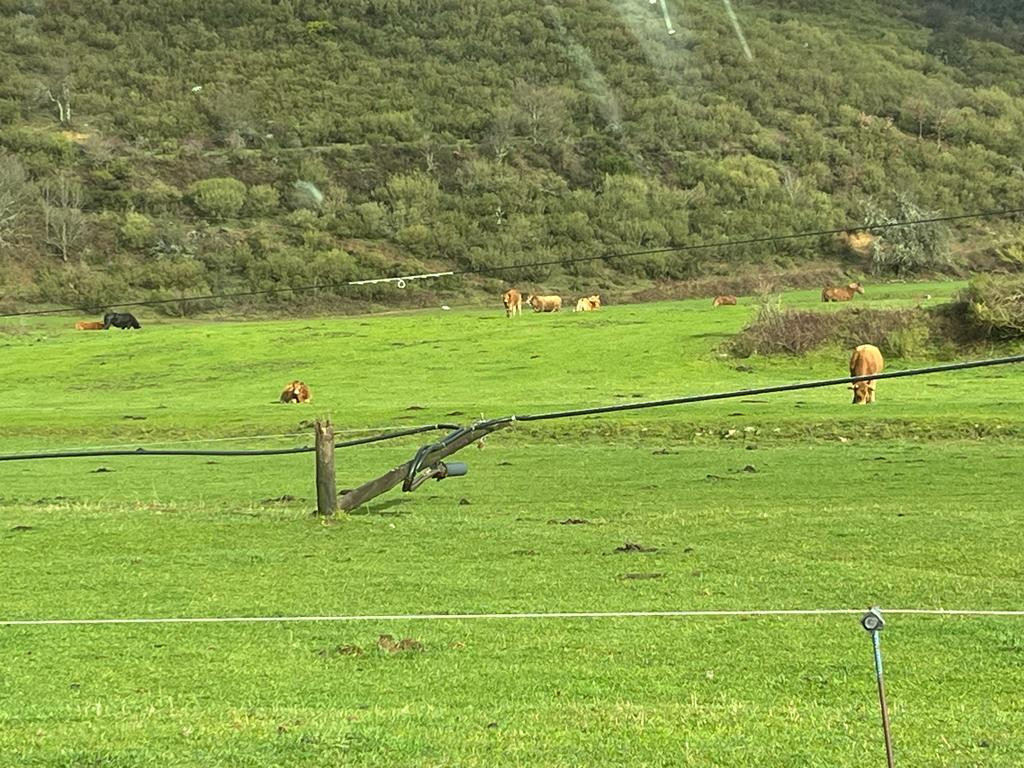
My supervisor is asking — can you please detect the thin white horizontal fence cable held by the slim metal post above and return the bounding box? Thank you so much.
[0,608,1024,627]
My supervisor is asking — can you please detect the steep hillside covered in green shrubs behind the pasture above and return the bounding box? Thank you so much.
[0,0,1024,309]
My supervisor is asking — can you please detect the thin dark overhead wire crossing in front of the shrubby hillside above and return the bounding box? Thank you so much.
[0,208,1024,317]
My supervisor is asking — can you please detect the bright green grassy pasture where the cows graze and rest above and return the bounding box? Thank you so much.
[0,284,1024,768]
